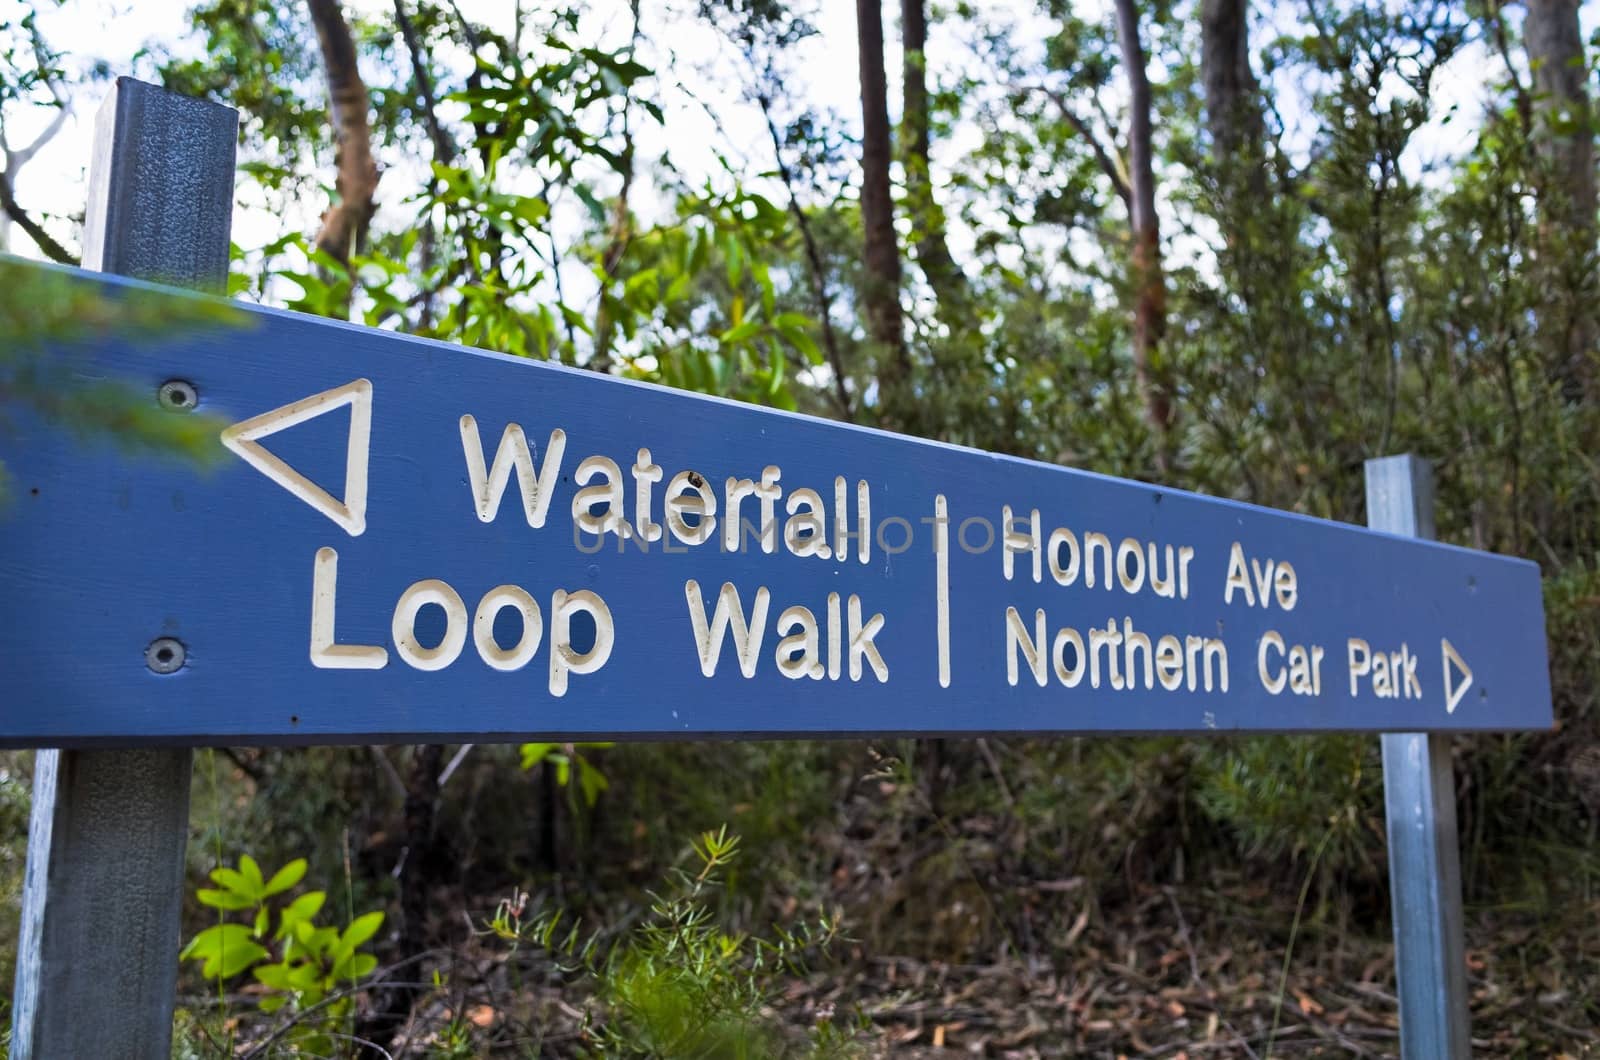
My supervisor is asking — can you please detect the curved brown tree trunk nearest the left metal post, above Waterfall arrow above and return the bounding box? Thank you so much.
[306,0,378,261]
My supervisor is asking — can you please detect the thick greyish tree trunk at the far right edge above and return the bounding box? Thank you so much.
[1523,0,1597,400]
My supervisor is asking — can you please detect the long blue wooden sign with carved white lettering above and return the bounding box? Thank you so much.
[0,265,1552,746]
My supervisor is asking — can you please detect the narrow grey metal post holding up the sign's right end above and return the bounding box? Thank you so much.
[1366,455,1472,1060]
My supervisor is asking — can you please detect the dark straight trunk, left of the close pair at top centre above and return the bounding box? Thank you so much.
[856,0,910,431]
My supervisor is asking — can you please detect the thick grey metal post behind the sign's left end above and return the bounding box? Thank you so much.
[11,78,238,1060]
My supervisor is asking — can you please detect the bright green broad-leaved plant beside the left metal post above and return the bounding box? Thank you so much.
[179,853,384,1054]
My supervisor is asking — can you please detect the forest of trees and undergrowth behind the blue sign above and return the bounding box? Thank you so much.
[0,0,1600,1057]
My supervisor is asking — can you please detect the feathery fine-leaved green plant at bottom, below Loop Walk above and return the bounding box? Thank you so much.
[490,826,856,1060]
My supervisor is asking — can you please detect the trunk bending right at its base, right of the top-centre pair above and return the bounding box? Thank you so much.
[901,0,968,317]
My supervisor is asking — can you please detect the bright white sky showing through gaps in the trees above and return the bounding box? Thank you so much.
[0,0,1574,270]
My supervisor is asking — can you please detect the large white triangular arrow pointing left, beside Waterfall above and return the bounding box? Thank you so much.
[222,379,373,538]
